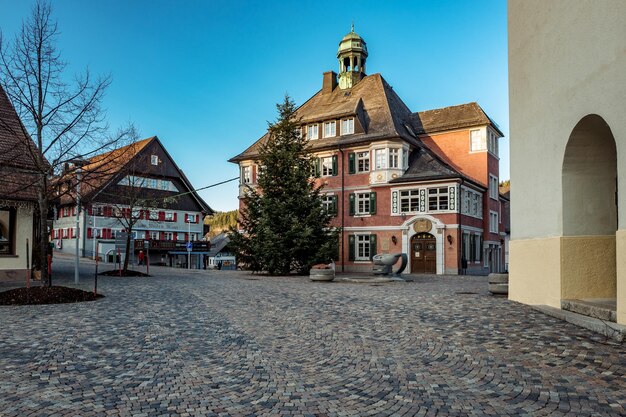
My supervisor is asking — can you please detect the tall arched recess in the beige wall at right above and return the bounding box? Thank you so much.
[560,114,618,299]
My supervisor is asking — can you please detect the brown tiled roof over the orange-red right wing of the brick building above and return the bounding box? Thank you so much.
[411,102,504,136]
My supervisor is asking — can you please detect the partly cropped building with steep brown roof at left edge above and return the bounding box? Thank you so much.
[0,87,45,281]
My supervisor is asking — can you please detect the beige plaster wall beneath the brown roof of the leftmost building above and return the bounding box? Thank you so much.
[0,206,33,281]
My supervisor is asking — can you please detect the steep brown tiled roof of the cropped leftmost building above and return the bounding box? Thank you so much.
[0,86,46,201]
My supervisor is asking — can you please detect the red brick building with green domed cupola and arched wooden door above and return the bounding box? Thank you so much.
[230,31,508,274]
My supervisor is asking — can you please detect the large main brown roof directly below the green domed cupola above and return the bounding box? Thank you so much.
[229,74,419,163]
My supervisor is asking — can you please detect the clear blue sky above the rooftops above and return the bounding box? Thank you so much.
[0,0,509,211]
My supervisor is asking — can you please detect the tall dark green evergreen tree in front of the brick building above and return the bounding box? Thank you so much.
[230,96,338,275]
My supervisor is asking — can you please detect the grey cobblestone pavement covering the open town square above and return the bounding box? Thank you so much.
[0,262,626,416]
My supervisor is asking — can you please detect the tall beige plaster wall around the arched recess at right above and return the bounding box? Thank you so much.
[509,0,626,323]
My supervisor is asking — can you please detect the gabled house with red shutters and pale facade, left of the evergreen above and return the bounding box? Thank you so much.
[51,136,213,268]
